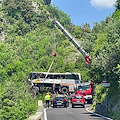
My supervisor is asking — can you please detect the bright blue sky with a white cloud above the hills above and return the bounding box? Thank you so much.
[52,0,116,28]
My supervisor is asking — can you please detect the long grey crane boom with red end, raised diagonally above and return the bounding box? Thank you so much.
[52,19,92,64]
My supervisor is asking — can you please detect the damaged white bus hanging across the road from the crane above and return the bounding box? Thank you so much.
[29,72,81,93]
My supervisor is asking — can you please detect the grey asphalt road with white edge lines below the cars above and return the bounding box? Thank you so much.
[46,104,106,120]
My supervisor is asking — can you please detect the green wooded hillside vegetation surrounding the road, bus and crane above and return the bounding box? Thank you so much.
[0,0,120,120]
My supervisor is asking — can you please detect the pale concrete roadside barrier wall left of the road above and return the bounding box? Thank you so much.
[28,100,44,120]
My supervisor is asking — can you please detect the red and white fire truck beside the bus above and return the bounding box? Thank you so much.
[75,81,95,103]
